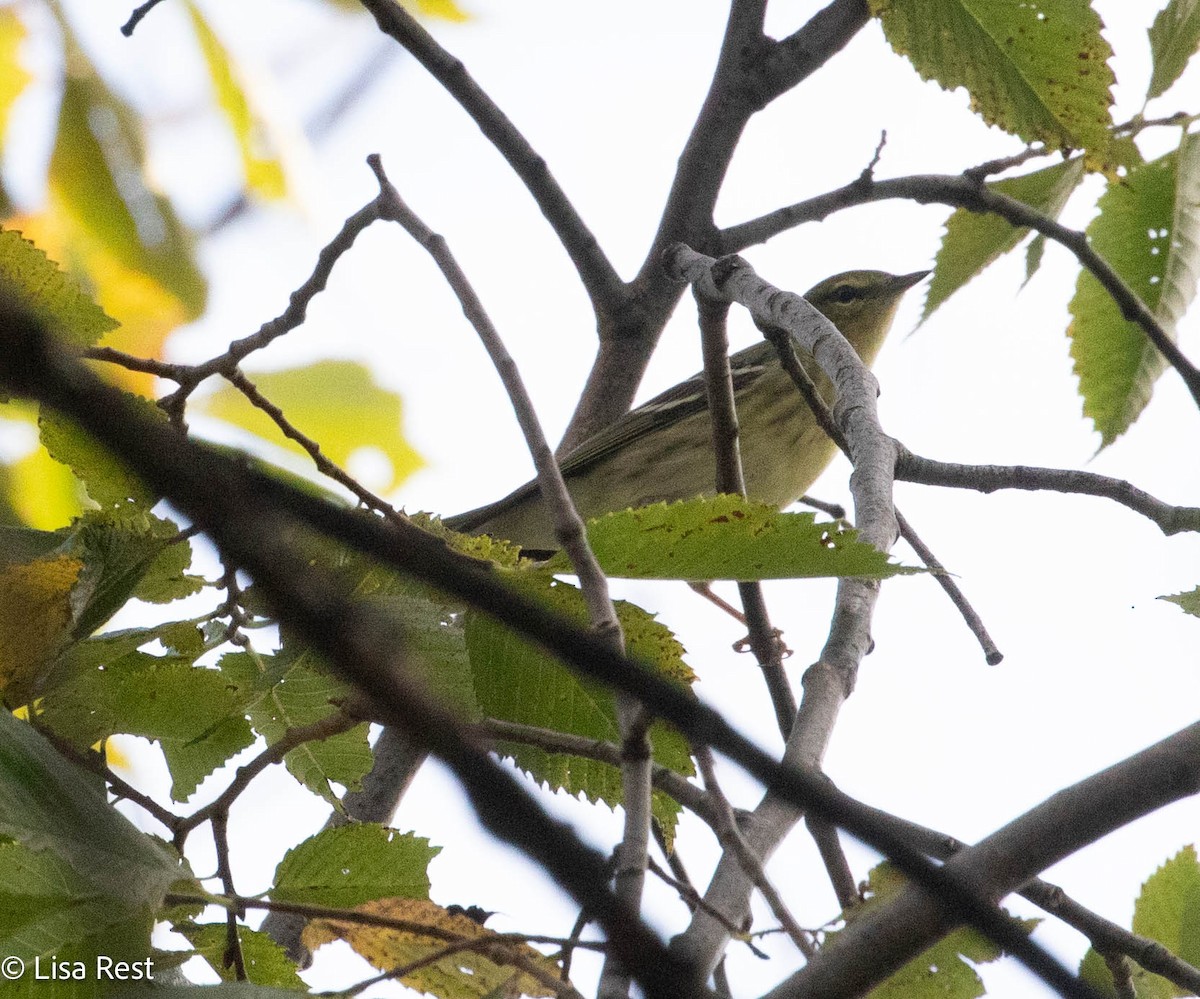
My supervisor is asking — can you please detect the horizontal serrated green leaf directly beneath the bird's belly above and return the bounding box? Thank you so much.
[550,496,919,581]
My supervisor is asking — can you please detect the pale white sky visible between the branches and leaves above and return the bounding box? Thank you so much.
[23,0,1200,995]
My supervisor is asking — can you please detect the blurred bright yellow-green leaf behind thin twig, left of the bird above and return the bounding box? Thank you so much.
[199,360,422,491]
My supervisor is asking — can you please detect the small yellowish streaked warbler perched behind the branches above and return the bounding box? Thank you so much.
[445,270,929,550]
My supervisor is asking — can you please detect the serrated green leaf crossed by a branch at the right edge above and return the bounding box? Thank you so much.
[1068,136,1200,448]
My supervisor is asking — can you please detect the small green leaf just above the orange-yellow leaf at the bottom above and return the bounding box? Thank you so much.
[270,822,442,909]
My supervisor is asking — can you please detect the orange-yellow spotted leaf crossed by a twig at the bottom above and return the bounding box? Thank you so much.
[302,898,558,999]
